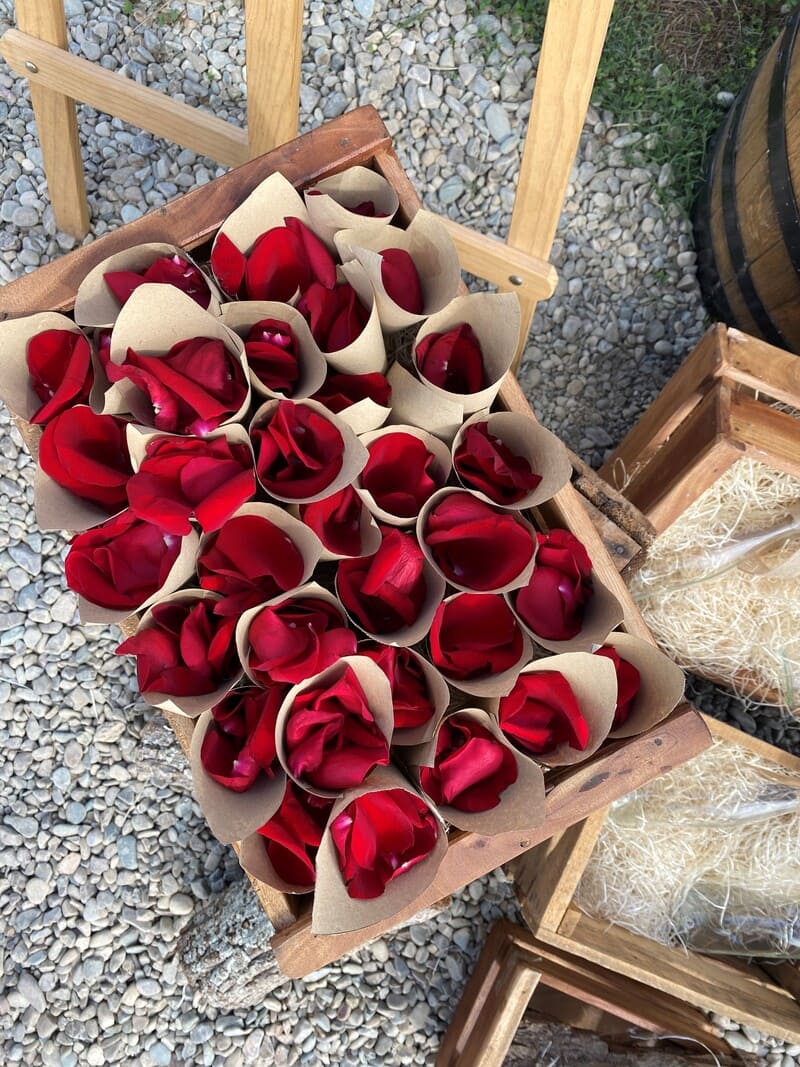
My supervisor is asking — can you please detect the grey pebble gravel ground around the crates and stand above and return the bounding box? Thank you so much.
[0,0,800,1067]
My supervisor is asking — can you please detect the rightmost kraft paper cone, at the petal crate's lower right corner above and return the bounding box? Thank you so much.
[595,631,686,738]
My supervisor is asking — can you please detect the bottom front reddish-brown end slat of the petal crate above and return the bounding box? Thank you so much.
[272,704,709,978]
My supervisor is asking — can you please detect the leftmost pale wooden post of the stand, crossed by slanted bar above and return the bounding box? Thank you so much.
[16,0,89,238]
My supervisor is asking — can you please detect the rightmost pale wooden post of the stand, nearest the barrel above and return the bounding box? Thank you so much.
[503,0,613,371]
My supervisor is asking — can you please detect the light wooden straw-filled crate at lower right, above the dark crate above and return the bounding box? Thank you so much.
[513,718,800,1041]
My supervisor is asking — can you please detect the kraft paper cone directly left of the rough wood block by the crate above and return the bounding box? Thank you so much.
[452,411,572,511]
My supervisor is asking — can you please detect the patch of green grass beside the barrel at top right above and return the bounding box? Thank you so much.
[473,0,786,209]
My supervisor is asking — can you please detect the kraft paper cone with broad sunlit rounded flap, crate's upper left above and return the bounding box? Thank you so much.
[103,285,251,426]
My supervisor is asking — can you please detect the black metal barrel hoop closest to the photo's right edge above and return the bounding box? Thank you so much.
[767,10,800,272]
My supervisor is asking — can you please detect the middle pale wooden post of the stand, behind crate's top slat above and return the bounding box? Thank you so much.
[244,0,303,158]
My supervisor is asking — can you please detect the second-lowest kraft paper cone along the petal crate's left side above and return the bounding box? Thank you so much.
[189,711,286,845]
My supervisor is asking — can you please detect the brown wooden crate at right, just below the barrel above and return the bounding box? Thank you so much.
[599,324,800,531]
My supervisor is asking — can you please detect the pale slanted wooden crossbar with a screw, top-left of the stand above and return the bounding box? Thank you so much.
[0,30,249,173]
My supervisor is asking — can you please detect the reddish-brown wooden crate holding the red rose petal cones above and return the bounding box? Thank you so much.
[0,107,709,977]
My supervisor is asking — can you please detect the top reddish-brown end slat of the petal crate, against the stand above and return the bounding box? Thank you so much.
[0,106,391,319]
